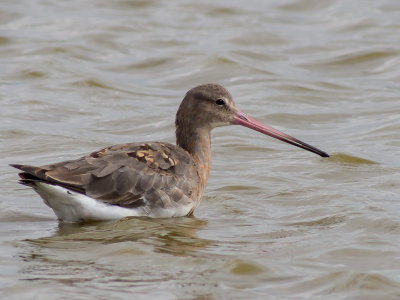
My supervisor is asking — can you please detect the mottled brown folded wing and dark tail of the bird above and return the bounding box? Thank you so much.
[12,143,199,208]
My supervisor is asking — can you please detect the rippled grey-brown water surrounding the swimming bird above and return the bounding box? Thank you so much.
[0,0,400,299]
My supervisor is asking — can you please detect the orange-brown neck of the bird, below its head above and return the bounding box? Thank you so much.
[176,124,211,186]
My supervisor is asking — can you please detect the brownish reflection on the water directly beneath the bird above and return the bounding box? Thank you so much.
[27,217,214,255]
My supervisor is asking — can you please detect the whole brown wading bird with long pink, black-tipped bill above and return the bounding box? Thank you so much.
[12,84,328,222]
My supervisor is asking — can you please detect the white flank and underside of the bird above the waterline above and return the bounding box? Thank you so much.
[34,182,193,222]
